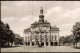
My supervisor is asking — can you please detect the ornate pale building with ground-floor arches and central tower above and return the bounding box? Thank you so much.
[24,7,59,46]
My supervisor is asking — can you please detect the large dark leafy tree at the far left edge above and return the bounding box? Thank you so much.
[0,21,14,47]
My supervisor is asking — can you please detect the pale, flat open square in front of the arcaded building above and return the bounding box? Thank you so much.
[1,46,80,52]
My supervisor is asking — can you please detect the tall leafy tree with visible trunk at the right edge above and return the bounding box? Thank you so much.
[72,22,80,47]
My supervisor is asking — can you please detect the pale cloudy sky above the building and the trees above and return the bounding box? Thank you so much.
[1,1,80,37]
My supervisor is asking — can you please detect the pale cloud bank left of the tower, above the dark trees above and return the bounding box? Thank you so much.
[2,15,39,36]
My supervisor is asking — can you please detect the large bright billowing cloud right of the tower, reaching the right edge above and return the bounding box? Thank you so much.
[45,6,80,36]
